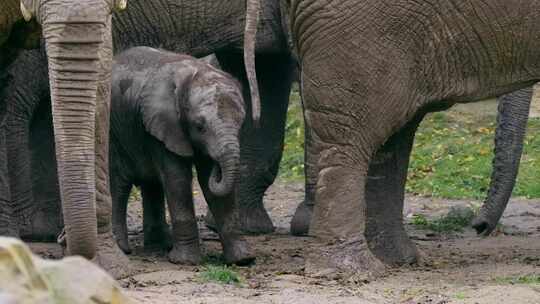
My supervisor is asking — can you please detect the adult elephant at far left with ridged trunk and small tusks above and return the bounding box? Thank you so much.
[0,0,130,274]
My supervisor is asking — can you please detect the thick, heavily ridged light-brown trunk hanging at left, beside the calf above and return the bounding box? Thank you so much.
[43,18,112,259]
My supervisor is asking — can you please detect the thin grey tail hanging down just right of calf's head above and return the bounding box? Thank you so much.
[244,0,261,125]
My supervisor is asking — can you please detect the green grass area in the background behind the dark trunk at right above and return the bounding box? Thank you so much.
[406,111,540,200]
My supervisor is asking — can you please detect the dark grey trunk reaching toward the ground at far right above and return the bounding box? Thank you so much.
[473,87,533,235]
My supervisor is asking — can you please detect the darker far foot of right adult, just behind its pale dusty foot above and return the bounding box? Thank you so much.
[366,226,420,265]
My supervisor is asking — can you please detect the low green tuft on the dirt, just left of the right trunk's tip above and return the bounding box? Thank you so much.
[411,208,474,233]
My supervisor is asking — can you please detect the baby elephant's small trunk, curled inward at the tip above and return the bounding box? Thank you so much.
[208,137,240,196]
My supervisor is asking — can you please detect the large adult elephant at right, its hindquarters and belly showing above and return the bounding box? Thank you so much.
[252,0,540,272]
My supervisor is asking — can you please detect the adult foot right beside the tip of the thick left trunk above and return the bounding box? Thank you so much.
[93,231,132,279]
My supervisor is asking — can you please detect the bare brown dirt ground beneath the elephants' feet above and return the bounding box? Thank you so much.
[30,182,540,304]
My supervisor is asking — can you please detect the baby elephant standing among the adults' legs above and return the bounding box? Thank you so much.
[110,47,253,264]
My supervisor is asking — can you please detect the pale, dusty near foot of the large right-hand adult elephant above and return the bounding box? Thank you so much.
[306,238,386,281]
